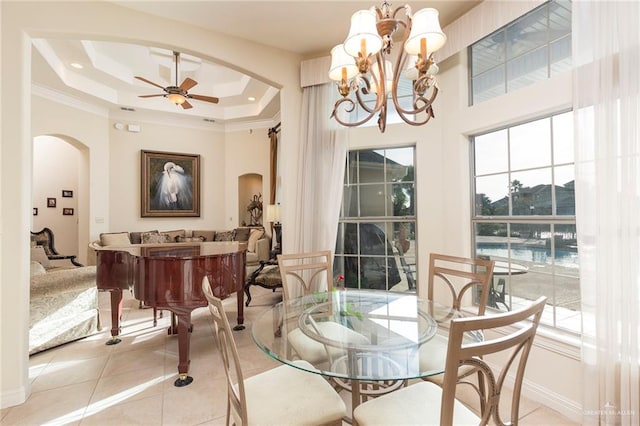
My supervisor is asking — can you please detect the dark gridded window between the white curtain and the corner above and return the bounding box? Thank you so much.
[334,147,417,291]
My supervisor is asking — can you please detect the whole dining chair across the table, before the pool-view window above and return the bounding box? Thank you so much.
[420,253,495,412]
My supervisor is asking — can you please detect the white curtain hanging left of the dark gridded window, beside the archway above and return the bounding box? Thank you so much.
[285,84,347,253]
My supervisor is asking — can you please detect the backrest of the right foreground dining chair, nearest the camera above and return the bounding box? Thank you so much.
[440,297,547,425]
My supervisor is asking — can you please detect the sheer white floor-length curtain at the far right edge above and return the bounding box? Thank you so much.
[573,1,640,425]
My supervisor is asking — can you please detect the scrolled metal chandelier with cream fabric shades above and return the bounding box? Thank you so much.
[329,1,447,132]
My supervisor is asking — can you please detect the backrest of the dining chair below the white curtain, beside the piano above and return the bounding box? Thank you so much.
[278,250,333,300]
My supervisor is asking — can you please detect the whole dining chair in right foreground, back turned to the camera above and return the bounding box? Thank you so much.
[353,297,546,426]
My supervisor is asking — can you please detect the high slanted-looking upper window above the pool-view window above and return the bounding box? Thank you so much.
[469,0,571,105]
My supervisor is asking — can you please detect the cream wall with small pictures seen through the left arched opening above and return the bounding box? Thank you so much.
[31,136,79,256]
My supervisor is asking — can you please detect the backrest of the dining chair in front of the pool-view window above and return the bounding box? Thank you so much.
[427,253,495,315]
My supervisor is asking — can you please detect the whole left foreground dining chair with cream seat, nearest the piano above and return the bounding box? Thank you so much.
[202,277,346,426]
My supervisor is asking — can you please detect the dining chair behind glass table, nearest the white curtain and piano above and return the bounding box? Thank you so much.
[278,250,406,401]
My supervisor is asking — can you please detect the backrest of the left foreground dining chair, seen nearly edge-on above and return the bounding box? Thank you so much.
[202,276,248,425]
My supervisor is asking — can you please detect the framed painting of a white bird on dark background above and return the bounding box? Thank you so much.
[140,150,200,217]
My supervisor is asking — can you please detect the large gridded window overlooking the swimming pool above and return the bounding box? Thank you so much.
[471,112,580,332]
